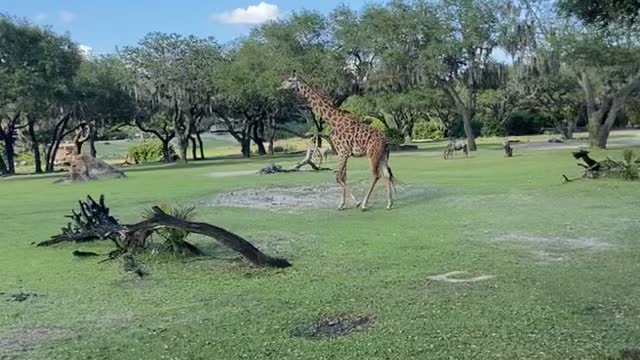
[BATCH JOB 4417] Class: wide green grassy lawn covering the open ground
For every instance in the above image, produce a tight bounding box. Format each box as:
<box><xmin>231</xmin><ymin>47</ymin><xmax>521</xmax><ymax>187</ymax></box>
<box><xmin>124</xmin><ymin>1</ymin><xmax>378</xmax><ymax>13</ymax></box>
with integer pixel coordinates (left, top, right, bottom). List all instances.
<box><xmin>0</xmin><ymin>144</ymin><xmax>640</xmax><ymax>359</ymax></box>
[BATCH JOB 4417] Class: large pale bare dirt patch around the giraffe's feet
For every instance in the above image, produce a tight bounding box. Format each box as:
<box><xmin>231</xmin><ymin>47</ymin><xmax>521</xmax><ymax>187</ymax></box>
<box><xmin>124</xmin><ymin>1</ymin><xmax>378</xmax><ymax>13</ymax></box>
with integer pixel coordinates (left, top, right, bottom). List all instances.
<box><xmin>205</xmin><ymin>181</ymin><xmax>436</xmax><ymax>210</ymax></box>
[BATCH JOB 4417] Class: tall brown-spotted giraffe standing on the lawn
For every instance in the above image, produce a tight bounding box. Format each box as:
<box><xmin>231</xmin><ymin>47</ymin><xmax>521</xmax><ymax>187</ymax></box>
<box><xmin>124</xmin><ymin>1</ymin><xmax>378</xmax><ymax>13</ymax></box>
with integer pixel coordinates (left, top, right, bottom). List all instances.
<box><xmin>281</xmin><ymin>72</ymin><xmax>394</xmax><ymax>210</ymax></box>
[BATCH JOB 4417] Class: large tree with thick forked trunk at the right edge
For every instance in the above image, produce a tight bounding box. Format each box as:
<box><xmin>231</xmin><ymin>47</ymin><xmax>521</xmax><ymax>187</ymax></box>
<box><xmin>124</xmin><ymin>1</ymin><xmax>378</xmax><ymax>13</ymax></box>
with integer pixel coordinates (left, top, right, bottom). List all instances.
<box><xmin>502</xmin><ymin>1</ymin><xmax>640</xmax><ymax>148</ymax></box>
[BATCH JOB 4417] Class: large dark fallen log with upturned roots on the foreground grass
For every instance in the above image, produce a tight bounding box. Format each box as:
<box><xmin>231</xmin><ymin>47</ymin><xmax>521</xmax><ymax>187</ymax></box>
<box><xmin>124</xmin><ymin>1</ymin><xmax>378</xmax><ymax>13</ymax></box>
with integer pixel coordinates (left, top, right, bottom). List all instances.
<box><xmin>37</xmin><ymin>195</ymin><xmax>291</xmax><ymax>268</ymax></box>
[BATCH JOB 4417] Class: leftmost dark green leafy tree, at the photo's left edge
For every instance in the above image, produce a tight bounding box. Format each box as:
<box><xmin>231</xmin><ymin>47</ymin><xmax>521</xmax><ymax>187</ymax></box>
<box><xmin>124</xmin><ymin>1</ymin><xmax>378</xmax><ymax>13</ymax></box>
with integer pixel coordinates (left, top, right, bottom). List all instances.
<box><xmin>0</xmin><ymin>17</ymin><xmax>80</xmax><ymax>172</ymax></box>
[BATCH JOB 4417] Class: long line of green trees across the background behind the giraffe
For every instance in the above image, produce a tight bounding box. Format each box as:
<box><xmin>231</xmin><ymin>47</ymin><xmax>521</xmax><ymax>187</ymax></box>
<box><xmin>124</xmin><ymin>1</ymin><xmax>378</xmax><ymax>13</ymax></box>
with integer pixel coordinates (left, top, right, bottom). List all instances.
<box><xmin>0</xmin><ymin>0</ymin><xmax>640</xmax><ymax>174</ymax></box>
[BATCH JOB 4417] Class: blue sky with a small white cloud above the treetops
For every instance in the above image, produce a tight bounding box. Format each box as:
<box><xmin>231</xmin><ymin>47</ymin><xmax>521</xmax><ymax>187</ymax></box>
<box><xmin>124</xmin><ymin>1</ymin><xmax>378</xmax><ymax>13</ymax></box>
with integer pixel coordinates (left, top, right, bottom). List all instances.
<box><xmin>0</xmin><ymin>0</ymin><xmax>382</xmax><ymax>54</ymax></box>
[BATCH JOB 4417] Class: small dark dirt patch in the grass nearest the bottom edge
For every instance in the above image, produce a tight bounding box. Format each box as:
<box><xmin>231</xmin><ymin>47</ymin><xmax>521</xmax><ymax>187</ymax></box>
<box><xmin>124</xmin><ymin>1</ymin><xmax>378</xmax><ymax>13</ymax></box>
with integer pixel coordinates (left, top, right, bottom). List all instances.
<box><xmin>291</xmin><ymin>315</ymin><xmax>373</xmax><ymax>339</ymax></box>
